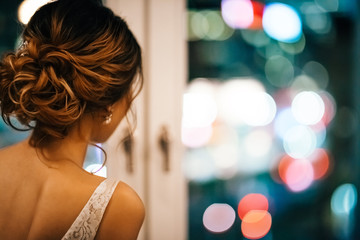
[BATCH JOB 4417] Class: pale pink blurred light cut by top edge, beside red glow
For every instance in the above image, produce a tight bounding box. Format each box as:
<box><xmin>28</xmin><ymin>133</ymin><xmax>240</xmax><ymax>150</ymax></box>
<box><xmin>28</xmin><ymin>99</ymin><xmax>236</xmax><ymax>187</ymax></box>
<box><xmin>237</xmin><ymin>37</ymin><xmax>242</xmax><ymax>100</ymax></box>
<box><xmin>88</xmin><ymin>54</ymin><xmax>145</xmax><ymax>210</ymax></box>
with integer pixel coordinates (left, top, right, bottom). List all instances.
<box><xmin>221</xmin><ymin>0</ymin><xmax>254</xmax><ymax>28</ymax></box>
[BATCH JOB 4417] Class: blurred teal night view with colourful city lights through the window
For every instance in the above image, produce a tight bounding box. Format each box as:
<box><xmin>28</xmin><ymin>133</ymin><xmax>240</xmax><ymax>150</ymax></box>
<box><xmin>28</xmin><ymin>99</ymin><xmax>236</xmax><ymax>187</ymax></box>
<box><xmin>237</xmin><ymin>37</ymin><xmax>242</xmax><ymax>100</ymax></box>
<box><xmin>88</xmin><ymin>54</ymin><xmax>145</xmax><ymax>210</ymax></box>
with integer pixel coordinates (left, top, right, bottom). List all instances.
<box><xmin>0</xmin><ymin>0</ymin><xmax>360</xmax><ymax>240</ymax></box>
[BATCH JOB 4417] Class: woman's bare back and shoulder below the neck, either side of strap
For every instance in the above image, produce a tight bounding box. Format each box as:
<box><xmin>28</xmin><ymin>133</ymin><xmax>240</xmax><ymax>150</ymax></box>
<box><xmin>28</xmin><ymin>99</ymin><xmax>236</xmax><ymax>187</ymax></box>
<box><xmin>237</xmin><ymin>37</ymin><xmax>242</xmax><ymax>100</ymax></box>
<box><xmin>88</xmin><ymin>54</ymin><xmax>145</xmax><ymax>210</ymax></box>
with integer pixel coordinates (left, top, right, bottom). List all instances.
<box><xmin>0</xmin><ymin>142</ymin><xmax>144</xmax><ymax>240</ymax></box>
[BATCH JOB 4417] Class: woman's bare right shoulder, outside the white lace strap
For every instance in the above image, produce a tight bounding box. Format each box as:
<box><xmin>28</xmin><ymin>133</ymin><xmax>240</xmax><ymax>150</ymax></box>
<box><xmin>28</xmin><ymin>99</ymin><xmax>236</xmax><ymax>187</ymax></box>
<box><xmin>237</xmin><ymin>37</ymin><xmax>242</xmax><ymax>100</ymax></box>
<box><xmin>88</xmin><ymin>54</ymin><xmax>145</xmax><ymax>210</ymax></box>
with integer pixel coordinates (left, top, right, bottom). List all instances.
<box><xmin>96</xmin><ymin>182</ymin><xmax>145</xmax><ymax>240</ymax></box>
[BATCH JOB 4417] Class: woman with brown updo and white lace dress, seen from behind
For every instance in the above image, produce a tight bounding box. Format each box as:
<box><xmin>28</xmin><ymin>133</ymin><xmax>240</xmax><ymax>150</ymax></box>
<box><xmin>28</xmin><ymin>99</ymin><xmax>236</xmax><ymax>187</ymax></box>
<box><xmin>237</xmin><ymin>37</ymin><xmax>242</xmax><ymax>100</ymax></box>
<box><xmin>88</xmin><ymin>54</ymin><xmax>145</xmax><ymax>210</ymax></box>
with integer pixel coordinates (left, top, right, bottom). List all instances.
<box><xmin>0</xmin><ymin>0</ymin><xmax>144</xmax><ymax>240</ymax></box>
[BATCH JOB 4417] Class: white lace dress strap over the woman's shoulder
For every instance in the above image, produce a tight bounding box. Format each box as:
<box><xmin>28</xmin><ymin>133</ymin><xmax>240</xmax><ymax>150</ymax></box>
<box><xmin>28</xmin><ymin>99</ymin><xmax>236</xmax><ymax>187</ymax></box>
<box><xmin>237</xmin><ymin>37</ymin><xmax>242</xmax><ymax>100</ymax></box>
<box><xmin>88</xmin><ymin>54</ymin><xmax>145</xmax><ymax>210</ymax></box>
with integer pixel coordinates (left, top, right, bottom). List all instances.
<box><xmin>62</xmin><ymin>179</ymin><xmax>118</xmax><ymax>240</ymax></box>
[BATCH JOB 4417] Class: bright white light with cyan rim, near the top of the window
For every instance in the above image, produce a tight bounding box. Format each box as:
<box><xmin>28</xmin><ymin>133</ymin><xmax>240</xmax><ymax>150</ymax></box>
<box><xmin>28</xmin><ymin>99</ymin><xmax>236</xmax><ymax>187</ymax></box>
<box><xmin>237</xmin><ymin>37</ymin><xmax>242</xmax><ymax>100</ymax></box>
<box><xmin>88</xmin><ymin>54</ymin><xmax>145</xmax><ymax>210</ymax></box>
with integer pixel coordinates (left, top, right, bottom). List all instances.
<box><xmin>263</xmin><ymin>3</ymin><xmax>302</xmax><ymax>43</ymax></box>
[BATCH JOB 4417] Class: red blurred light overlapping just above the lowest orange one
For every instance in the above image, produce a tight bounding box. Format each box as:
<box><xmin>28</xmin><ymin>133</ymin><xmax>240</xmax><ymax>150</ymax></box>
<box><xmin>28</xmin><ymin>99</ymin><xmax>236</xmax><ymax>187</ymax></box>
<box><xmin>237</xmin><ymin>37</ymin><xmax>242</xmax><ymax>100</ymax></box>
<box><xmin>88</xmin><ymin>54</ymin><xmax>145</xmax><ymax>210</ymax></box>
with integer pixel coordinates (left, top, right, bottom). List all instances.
<box><xmin>238</xmin><ymin>193</ymin><xmax>269</xmax><ymax>220</ymax></box>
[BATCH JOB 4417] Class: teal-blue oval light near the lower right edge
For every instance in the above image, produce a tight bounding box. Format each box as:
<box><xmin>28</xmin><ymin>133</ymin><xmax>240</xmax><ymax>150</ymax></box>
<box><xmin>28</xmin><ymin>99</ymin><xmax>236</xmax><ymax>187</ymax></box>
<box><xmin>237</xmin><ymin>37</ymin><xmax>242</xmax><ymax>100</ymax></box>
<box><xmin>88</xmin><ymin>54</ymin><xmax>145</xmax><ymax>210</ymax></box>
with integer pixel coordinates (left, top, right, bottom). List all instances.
<box><xmin>331</xmin><ymin>183</ymin><xmax>358</xmax><ymax>215</ymax></box>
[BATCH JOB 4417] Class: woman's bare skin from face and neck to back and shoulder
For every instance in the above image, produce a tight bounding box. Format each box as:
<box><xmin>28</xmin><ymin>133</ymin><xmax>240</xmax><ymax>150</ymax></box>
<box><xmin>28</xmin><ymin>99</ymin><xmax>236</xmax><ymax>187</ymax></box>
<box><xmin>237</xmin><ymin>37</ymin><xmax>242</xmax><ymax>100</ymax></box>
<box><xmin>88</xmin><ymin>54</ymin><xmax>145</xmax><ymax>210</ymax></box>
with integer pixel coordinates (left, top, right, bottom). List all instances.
<box><xmin>0</xmin><ymin>96</ymin><xmax>144</xmax><ymax>240</ymax></box>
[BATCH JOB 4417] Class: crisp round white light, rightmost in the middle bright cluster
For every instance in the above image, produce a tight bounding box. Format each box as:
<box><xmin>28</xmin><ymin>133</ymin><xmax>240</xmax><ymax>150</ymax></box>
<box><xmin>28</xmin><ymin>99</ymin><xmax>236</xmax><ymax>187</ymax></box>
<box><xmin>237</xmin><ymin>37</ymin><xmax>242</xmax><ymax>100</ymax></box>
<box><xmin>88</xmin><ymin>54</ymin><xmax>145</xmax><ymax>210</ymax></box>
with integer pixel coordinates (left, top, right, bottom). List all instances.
<box><xmin>291</xmin><ymin>91</ymin><xmax>325</xmax><ymax>125</ymax></box>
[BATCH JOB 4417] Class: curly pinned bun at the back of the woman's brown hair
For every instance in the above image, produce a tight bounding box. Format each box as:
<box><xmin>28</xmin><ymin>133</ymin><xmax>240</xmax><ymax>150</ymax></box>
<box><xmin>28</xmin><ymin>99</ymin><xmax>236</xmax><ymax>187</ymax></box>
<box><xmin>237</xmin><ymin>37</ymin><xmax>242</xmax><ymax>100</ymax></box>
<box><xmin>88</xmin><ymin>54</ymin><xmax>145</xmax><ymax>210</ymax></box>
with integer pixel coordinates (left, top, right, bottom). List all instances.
<box><xmin>0</xmin><ymin>43</ymin><xmax>85</xmax><ymax>137</ymax></box>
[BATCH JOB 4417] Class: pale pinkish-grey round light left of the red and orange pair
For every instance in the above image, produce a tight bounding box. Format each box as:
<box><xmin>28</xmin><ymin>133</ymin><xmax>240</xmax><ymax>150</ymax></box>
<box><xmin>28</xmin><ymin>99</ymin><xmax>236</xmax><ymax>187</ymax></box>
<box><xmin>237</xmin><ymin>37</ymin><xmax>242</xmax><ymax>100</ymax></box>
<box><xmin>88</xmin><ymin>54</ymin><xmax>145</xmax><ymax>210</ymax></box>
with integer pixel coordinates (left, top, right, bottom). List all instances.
<box><xmin>203</xmin><ymin>203</ymin><xmax>236</xmax><ymax>233</ymax></box>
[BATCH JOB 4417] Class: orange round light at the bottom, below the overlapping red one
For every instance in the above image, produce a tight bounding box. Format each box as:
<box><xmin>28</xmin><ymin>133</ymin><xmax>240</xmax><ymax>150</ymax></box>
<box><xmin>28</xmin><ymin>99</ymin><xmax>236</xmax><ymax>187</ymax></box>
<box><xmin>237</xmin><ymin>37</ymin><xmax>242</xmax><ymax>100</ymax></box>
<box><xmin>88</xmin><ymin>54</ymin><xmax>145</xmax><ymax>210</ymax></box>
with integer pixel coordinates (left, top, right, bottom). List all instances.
<box><xmin>241</xmin><ymin>210</ymin><xmax>272</xmax><ymax>239</ymax></box>
